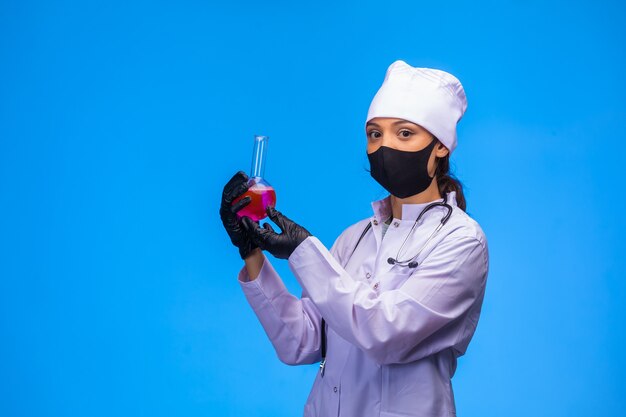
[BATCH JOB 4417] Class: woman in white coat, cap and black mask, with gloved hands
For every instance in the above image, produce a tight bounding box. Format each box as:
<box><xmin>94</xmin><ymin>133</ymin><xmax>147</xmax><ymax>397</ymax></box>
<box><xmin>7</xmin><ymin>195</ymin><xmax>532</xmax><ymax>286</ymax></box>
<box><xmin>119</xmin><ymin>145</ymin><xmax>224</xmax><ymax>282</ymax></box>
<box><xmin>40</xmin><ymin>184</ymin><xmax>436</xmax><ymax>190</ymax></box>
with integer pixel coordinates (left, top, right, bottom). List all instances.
<box><xmin>220</xmin><ymin>61</ymin><xmax>489</xmax><ymax>417</ymax></box>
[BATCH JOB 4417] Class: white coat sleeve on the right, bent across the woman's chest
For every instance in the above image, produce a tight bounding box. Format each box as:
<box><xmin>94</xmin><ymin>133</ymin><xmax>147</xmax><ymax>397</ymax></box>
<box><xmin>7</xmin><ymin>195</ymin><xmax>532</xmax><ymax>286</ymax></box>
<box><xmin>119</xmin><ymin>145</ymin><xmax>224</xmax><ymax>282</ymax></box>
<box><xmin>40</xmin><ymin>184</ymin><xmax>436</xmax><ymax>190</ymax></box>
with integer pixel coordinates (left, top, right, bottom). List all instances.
<box><xmin>289</xmin><ymin>236</ymin><xmax>488</xmax><ymax>364</ymax></box>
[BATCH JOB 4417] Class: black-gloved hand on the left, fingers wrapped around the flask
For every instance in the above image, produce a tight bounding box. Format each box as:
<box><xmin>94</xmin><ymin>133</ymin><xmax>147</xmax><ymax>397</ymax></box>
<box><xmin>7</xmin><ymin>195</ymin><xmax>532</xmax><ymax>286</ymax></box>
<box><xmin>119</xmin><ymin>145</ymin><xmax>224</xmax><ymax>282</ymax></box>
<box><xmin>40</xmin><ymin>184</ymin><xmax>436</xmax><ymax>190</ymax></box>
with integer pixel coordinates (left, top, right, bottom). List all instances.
<box><xmin>220</xmin><ymin>171</ymin><xmax>259</xmax><ymax>259</ymax></box>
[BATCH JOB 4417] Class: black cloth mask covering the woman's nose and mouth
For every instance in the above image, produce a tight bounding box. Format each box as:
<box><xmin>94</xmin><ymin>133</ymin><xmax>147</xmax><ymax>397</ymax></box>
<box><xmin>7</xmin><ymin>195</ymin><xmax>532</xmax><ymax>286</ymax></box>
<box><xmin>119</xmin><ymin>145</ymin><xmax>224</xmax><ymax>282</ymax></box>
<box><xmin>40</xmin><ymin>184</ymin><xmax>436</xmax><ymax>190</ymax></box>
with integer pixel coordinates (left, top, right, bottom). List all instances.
<box><xmin>367</xmin><ymin>138</ymin><xmax>436</xmax><ymax>198</ymax></box>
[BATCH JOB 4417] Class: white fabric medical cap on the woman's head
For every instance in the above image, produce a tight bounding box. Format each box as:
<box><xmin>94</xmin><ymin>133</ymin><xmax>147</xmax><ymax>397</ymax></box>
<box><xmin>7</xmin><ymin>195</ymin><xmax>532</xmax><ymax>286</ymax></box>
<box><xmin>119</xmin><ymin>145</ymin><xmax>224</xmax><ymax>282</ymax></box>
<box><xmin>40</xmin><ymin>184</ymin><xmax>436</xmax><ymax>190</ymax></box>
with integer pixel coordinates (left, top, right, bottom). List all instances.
<box><xmin>366</xmin><ymin>61</ymin><xmax>467</xmax><ymax>153</ymax></box>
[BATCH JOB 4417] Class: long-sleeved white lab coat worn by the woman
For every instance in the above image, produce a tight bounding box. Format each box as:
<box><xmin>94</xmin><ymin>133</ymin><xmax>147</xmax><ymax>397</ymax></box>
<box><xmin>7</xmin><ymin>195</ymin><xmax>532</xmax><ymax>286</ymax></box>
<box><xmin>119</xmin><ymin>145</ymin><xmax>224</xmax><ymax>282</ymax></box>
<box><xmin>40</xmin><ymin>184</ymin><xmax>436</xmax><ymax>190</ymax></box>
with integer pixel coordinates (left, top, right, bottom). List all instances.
<box><xmin>238</xmin><ymin>192</ymin><xmax>489</xmax><ymax>417</ymax></box>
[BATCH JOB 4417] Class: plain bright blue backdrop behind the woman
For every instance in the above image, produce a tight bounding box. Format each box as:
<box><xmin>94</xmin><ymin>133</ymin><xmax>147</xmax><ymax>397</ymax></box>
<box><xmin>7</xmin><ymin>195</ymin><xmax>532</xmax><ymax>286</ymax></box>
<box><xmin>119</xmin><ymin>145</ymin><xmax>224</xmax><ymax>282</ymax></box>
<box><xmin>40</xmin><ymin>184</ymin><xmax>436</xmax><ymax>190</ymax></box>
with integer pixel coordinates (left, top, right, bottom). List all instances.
<box><xmin>0</xmin><ymin>0</ymin><xmax>626</xmax><ymax>417</ymax></box>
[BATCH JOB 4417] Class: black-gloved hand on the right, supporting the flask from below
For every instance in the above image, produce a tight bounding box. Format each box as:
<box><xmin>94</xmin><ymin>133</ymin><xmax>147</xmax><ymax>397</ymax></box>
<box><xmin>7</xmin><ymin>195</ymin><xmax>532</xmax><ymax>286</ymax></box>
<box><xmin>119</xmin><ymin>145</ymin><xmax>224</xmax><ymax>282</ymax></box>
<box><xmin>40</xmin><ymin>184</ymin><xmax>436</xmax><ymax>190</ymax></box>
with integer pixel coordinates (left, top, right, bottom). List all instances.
<box><xmin>241</xmin><ymin>207</ymin><xmax>311</xmax><ymax>259</ymax></box>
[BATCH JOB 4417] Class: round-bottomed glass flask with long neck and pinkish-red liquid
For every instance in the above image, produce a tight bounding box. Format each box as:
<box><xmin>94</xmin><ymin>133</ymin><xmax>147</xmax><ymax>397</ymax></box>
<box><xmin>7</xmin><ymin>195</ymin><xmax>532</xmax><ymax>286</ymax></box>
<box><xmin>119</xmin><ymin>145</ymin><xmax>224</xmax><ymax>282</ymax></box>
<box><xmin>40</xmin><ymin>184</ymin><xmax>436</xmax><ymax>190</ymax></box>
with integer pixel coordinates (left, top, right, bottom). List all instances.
<box><xmin>233</xmin><ymin>135</ymin><xmax>276</xmax><ymax>221</ymax></box>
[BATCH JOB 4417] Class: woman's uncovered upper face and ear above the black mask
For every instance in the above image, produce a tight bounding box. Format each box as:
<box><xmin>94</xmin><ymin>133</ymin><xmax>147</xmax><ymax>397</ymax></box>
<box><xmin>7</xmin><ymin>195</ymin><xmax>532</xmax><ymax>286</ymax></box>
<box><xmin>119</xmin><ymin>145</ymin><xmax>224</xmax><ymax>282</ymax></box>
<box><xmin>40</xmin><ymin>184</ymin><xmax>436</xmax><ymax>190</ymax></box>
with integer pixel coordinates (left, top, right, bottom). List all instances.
<box><xmin>365</xmin><ymin>117</ymin><xmax>448</xmax><ymax>176</ymax></box>
